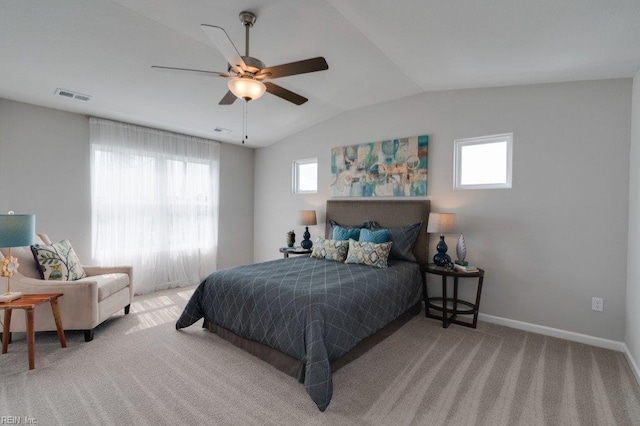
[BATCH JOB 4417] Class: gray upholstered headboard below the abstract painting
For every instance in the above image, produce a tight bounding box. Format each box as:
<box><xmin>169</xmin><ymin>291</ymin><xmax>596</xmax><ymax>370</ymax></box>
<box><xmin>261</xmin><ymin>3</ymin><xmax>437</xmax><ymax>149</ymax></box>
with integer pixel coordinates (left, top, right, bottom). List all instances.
<box><xmin>325</xmin><ymin>200</ymin><xmax>430</xmax><ymax>265</ymax></box>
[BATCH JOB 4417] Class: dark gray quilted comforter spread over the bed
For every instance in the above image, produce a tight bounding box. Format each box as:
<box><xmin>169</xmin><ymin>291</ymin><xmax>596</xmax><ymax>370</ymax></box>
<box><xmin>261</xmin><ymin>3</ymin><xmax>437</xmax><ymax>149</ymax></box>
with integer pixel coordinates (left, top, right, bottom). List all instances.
<box><xmin>176</xmin><ymin>257</ymin><xmax>422</xmax><ymax>411</ymax></box>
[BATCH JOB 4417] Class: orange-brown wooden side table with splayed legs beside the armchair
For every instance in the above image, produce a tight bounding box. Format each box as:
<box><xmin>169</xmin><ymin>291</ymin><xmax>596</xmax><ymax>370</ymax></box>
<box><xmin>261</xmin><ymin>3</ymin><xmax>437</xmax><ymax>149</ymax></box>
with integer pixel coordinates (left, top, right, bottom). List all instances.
<box><xmin>0</xmin><ymin>293</ymin><xmax>67</xmax><ymax>370</ymax></box>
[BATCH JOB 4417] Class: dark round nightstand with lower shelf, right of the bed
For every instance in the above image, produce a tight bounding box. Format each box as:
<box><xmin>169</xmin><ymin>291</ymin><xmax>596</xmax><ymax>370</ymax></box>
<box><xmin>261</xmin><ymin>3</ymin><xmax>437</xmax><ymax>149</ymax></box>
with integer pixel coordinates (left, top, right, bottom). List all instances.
<box><xmin>424</xmin><ymin>263</ymin><xmax>484</xmax><ymax>328</ymax></box>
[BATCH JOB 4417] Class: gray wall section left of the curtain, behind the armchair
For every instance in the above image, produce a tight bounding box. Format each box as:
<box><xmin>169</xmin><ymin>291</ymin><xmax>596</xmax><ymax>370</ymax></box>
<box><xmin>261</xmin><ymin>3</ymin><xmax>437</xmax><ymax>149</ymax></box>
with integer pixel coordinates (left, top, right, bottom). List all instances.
<box><xmin>0</xmin><ymin>99</ymin><xmax>91</xmax><ymax>258</ymax></box>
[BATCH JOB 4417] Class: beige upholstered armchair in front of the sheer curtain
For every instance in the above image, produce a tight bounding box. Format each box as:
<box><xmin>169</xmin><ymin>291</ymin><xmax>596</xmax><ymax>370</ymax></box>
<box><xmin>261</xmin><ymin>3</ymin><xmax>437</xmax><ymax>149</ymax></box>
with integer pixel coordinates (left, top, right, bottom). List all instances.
<box><xmin>0</xmin><ymin>234</ymin><xmax>133</xmax><ymax>342</ymax></box>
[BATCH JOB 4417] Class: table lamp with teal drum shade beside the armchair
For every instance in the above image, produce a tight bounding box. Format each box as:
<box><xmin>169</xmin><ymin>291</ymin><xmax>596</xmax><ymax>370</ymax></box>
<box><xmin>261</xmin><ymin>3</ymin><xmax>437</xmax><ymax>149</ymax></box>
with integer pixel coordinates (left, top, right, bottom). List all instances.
<box><xmin>0</xmin><ymin>212</ymin><xmax>36</xmax><ymax>302</ymax></box>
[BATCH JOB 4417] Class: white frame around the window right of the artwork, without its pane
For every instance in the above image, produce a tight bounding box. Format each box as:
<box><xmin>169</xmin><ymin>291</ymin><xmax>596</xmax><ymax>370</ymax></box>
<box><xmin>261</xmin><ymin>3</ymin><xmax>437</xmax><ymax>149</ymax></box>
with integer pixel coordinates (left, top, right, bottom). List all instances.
<box><xmin>453</xmin><ymin>133</ymin><xmax>513</xmax><ymax>189</ymax></box>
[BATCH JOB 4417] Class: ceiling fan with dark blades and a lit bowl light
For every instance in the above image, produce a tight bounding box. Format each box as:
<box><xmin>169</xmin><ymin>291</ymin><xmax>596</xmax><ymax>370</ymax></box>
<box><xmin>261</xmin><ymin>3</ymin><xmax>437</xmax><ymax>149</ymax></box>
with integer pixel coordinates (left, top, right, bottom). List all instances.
<box><xmin>152</xmin><ymin>11</ymin><xmax>329</xmax><ymax>105</ymax></box>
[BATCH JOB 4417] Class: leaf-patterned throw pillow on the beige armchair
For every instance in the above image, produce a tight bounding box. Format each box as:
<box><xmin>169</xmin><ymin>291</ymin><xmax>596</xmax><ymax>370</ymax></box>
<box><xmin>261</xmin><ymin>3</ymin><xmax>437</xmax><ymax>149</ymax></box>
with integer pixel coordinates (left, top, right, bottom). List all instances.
<box><xmin>31</xmin><ymin>240</ymin><xmax>87</xmax><ymax>281</ymax></box>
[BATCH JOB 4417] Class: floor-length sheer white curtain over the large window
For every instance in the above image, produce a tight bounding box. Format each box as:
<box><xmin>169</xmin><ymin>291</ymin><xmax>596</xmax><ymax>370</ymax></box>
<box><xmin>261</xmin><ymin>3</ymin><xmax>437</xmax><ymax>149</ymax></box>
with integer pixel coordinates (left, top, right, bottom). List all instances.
<box><xmin>89</xmin><ymin>117</ymin><xmax>220</xmax><ymax>294</ymax></box>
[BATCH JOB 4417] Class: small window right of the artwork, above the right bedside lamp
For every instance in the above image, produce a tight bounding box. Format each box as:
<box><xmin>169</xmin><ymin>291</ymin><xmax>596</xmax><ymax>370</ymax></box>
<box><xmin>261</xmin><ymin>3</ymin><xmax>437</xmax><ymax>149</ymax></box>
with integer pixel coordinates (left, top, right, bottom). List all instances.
<box><xmin>453</xmin><ymin>133</ymin><xmax>513</xmax><ymax>189</ymax></box>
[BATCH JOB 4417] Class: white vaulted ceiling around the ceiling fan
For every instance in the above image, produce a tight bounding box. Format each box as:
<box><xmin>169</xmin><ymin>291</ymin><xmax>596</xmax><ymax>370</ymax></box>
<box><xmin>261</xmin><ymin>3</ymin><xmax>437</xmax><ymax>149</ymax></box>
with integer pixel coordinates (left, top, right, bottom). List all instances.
<box><xmin>0</xmin><ymin>0</ymin><xmax>640</xmax><ymax>147</ymax></box>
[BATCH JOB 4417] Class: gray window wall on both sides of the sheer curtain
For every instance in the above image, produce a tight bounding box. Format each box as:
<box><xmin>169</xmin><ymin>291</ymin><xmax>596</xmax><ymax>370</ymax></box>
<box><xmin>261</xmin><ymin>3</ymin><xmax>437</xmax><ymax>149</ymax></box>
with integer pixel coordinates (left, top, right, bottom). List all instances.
<box><xmin>0</xmin><ymin>98</ymin><xmax>253</xmax><ymax>269</ymax></box>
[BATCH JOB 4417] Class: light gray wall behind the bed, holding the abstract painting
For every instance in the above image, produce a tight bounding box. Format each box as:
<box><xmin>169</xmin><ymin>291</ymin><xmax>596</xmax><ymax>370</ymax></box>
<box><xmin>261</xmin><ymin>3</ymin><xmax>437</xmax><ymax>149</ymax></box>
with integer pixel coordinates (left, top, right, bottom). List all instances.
<box><xmin>255</xmin><ymin>79</ymin><xmax>632</xmax><ymax>341</ymax></box>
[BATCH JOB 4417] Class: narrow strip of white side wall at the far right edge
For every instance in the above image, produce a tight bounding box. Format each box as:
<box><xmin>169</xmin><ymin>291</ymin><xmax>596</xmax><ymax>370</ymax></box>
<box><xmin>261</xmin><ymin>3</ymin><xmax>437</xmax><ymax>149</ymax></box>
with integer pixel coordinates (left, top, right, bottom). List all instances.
<box><xmin>625</xmin><ymin>71</ymin><xmax>640</xmax><ymax>372</ymax></box>
